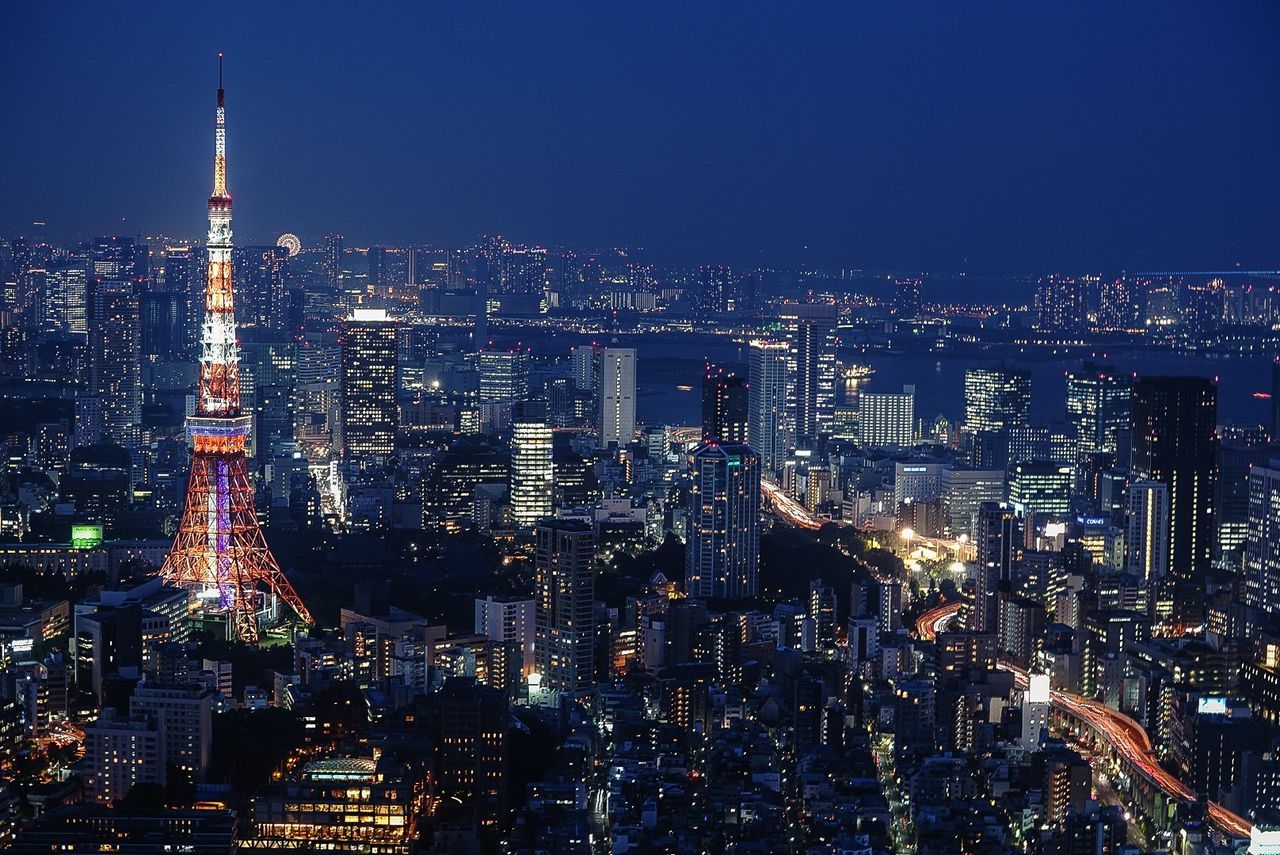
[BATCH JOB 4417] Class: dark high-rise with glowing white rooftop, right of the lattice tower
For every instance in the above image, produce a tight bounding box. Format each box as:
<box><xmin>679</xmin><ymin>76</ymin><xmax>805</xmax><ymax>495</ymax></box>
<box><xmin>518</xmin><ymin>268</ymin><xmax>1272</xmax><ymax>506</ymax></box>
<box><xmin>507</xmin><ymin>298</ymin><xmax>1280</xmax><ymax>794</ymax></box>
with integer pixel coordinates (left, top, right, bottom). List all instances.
<box><xmin>342</xmin><ymin>308</ymin><xmax>399</xmax><ymax>463</ymax></box>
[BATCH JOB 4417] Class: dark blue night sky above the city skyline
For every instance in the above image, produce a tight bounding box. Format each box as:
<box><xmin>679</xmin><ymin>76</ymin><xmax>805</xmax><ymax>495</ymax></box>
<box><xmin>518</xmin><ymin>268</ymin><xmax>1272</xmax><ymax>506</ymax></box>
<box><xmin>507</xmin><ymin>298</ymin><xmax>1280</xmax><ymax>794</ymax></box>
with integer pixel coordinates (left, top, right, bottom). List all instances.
<box><xmin>0</xmin><ymin>0</ymin><xmax>1280</xmax><ymax>271</ymax></box>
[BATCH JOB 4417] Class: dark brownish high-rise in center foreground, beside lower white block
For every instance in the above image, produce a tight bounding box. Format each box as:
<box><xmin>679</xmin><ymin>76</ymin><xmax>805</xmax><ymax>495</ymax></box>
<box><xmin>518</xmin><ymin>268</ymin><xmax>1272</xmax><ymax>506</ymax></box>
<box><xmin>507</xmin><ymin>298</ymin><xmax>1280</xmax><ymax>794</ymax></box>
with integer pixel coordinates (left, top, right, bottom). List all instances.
<box><xmin>534</xmin><ymin>520</ymin><xmax>595</xmax><ymax>698</ymax></box>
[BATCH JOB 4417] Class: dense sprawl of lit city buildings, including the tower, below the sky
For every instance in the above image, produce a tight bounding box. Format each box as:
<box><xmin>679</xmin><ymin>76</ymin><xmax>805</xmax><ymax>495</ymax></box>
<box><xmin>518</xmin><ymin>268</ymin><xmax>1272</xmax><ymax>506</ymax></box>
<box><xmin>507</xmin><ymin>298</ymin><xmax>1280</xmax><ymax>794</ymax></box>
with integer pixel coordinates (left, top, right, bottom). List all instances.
<box><xmin>0</xmin><ymin>71</ymin><xmax>1280</xmax><ymax>855</ymax></box>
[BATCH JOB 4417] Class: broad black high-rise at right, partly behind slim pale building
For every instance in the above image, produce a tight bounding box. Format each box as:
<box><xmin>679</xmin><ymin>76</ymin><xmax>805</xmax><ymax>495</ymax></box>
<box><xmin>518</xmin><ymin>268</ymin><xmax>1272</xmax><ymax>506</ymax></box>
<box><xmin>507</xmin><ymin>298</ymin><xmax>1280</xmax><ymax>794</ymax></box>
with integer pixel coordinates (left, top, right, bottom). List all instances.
<box><xmin>1129</xmin><ymin>376</ymin><xmax>1217</xmax><ymax>626</ymax></box>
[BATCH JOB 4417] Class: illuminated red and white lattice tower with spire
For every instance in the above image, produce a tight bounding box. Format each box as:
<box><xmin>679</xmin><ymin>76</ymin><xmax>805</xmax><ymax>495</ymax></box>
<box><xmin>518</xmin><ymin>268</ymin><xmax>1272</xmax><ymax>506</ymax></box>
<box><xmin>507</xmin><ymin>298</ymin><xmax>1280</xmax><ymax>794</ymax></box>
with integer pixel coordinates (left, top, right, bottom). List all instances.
<box><xmin>160</xmin><ymin>54</ymin><xmax>312</xmax><ymax>643</ymax></box>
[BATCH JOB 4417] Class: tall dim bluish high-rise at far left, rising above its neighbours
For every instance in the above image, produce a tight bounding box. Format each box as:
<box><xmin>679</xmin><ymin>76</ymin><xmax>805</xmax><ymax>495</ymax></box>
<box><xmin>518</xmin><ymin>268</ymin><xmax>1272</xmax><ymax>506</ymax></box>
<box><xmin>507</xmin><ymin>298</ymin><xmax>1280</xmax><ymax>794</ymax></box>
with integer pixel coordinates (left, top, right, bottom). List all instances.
<box><xmin>88</xmin><ymin>275</ymin><xmax>142</xmax><ymax>447</ymax></box>
